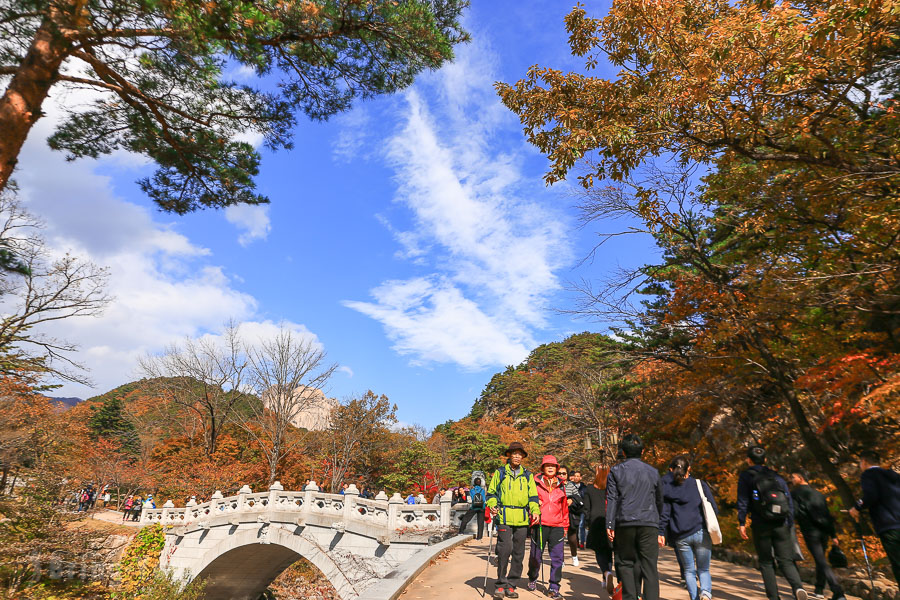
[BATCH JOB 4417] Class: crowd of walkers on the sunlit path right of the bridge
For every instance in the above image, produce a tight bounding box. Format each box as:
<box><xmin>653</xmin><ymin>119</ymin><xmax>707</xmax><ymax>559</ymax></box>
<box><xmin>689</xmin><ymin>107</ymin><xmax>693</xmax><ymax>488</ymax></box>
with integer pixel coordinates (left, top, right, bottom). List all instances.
<box><xmin>474</xmin><ymin>434</ymin><xmax>900</xmax><ymax>600</ymax></box>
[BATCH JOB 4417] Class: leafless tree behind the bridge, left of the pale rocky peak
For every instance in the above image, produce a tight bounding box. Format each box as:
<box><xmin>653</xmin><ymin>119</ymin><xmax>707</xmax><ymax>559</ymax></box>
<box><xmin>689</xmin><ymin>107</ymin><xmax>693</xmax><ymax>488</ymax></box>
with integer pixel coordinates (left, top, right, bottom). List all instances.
<box><xmin>140</xmin><ymin>323</ymin><xmax>249</xmax><ymax>456</ymax></box>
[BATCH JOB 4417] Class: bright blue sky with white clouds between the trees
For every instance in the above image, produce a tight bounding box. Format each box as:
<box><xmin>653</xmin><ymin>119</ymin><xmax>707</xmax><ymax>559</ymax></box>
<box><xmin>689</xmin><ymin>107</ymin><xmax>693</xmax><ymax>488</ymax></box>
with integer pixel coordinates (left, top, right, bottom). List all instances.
<box><xmin>16</xmin><ymin>1</ymin><xmax>652</xmax><ymax>427</ymax></box>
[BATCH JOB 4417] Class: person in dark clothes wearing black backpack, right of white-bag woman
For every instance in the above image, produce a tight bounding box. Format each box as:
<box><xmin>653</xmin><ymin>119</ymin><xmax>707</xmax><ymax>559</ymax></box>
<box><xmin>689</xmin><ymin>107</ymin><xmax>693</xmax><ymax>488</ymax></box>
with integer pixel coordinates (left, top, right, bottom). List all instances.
<box><xmin>737</xmin><ymin>446</ymin><xmax>809</xmax><ymax>600</ymax></box>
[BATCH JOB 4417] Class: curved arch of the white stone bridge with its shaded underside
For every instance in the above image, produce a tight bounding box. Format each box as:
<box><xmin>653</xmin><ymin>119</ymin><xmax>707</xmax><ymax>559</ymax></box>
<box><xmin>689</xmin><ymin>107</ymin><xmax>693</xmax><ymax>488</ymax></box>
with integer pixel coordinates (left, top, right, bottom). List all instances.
<box><xmin>185</xmin><ymin>528</ymin><xmax>358</xmax><ymax>600</ymax></box>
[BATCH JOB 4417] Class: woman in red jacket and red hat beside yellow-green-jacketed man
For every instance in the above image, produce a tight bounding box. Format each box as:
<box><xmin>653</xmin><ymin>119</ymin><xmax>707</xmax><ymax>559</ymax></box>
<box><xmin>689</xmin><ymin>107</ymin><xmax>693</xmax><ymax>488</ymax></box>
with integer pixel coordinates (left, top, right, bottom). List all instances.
<box><xmin>528</xmin><ymin>455</ymin><xmax>569</xmax><ymax>598</ymax></box>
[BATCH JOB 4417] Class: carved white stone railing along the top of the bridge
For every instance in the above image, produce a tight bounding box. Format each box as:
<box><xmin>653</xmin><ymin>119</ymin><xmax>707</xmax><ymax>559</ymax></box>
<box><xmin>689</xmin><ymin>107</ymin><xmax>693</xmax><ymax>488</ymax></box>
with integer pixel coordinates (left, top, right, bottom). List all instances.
<box><xmin>141</xmin><ymin>481</ymin><xmax>468</xmax><ymax>537</ymax></box>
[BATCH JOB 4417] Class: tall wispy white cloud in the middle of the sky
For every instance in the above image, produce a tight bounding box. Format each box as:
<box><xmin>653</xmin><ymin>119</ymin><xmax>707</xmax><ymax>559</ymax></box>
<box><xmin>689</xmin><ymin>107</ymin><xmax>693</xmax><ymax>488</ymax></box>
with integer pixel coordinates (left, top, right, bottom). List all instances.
<box><xmin>345</xmin><ymin>45</ymin><xmax>570</xmax><ymax>369</ymax></box>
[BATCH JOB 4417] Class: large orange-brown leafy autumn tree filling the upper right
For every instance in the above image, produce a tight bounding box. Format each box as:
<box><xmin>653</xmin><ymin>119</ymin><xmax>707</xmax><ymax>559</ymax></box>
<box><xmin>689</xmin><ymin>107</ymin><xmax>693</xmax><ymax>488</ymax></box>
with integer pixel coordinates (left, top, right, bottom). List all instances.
<box><xmin>498</xmin><ymin>0</ymin><xmax>900</xmax><ymax>503</ymax></box>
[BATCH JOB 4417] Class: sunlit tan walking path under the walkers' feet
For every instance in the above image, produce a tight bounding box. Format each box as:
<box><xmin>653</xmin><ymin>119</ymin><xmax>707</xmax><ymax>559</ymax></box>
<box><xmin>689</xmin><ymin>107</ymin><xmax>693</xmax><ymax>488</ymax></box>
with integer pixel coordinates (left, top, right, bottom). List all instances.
<box><xmin>401</xmin><ymin>535</ymin><xmax>858</xmax><ymax>600</ymax></box>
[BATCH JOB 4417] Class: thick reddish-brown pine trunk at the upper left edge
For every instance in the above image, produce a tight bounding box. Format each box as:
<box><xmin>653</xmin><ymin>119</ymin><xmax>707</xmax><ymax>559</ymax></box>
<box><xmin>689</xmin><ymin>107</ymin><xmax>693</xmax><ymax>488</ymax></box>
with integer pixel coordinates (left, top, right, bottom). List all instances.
<box><xmin>0</xmin><ymin>20</ymin><xmax>71</xmax><ymax>191</ymax></box>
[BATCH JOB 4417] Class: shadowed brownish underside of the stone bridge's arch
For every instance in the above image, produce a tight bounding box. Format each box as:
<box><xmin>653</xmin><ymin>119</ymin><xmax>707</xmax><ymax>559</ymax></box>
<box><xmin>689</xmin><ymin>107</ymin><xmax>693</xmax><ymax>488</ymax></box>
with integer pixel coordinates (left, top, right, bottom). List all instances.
<box><xmin>199</xmin><ymin>544</ymin><xmax>300</xmax><ymax>600</ymax></box>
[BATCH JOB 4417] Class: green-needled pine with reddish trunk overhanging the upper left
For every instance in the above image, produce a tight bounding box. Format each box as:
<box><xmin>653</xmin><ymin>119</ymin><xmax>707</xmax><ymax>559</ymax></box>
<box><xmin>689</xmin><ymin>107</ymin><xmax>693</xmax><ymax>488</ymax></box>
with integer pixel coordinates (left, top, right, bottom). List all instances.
<box><xmin>0</xmin><ymin>0</ymin><xmax>467</xmax><ymax>214</ymax></box>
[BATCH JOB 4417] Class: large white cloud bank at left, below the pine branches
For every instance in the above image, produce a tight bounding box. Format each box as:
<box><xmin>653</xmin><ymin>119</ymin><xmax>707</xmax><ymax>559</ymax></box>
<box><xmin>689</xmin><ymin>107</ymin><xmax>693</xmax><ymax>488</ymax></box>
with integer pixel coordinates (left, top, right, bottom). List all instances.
<box><xmin>9</xmin><ymin>84</ymin><xmax>315</xmax><ymax>397</ymax></box>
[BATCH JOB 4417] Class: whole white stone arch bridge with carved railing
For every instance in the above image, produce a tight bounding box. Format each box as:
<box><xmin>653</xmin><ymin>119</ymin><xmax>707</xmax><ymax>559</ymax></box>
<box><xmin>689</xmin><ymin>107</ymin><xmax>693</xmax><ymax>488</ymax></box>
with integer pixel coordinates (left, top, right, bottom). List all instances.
<box><xmin>141</xmin><ymin>482</ymin><xmax>469</xmax><ymax>600</ymax></box>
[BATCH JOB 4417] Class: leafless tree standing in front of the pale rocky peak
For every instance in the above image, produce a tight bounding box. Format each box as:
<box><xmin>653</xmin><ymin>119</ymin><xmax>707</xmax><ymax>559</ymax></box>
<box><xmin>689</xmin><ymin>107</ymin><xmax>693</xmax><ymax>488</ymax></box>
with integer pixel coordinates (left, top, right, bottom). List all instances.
<box><xmin>235</xmin><ymin>326</ymin><xmax>337</xmax><ymax>485</ymax></box>
